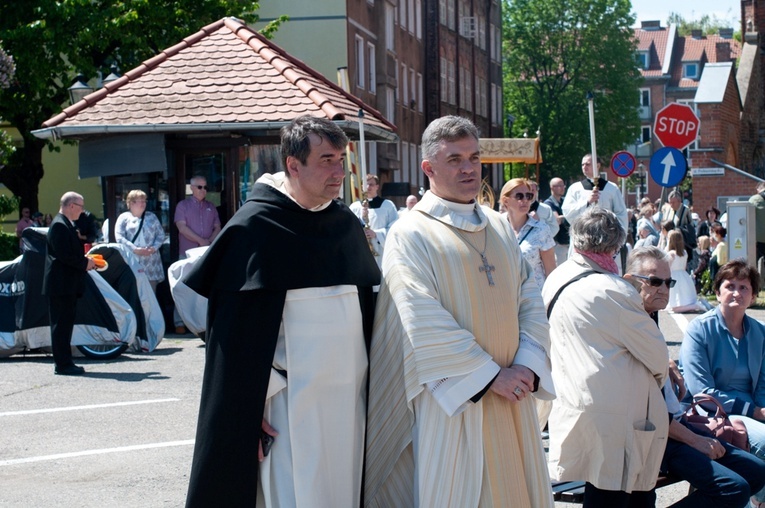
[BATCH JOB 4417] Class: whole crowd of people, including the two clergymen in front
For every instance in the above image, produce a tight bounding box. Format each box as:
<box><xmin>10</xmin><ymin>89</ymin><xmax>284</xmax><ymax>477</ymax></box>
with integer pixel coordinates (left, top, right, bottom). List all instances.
<box><xmin>17</xmin><ymin>112</ymin><xmax>765</xmax><ymax>508</ymax></box>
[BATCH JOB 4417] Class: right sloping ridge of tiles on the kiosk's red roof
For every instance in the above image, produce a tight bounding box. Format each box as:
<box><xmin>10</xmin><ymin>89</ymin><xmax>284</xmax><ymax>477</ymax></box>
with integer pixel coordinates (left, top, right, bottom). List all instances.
<box><xmin>222</xmin><ymin>17</ymin><xmax>396</xmax><ymax>130</ymax></box>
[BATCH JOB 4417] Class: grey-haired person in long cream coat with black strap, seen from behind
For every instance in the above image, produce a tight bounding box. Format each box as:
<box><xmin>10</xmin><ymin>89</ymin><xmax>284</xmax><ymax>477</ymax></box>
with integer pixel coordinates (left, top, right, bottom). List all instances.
<box><xmin>542</xmin><ymin>207</ymin><xmax>669</xmax><ymax>507</ymax></box>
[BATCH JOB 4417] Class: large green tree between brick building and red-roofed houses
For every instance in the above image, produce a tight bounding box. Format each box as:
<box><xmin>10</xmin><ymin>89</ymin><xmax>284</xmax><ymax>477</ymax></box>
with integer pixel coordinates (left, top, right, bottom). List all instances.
<box><xmin>503</xmin><ymin>0</ymin><xmax>642</xmax><ymax>180</ymax></box>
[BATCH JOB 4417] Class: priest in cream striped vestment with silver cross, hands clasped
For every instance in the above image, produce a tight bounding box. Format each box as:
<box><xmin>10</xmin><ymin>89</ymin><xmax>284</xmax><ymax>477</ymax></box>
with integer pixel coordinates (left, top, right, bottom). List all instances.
<box><xmin>364</xmin><ymin>116</ymin><xmax>554</xmax><ymax>508</ymax></box>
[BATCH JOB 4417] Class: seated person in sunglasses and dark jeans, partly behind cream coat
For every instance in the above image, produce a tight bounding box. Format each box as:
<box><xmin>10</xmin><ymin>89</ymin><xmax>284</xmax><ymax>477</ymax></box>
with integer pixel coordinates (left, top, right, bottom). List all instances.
<box><xmin>624</xmin><ymin>251</ymin><xmax>765</xmax><ymax>508</ymax></box>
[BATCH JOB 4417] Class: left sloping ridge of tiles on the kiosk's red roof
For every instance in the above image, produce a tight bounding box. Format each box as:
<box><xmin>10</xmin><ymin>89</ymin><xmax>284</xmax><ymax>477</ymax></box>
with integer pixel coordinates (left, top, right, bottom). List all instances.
<box><xmin>42</xmin><ymin>18</ymin><xmax>225</xmax><ymax>127</ymax></box>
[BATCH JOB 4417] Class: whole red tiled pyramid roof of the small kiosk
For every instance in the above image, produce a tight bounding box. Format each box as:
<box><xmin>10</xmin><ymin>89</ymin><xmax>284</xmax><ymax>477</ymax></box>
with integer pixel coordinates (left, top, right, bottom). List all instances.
<box><xmin>43</xmin><ymin>18</ymin><xmax>395</xmax><ymax>139</ymax></box>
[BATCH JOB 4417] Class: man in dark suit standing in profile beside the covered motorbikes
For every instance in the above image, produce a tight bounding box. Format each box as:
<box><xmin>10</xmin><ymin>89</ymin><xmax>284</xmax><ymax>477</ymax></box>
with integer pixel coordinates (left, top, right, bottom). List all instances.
<box><xmin>43</xmin><ymin>192</ymin><xmax>96</xmax><ymax>376</ymax></box>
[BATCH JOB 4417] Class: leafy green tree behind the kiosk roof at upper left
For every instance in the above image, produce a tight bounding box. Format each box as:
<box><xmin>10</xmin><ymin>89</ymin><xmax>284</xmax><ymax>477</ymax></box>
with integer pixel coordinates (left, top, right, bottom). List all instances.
<box><xmin>0</xmin><ymin>0</ymin><xmax>282</xmax><ymax>214</ymax></box>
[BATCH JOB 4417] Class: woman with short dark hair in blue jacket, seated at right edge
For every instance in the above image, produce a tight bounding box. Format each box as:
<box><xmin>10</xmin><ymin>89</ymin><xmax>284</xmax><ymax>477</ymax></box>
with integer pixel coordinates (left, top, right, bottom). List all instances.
<box><xmin>680</xmin><ymin>259</ymin><xmax>765</xmax><ymax>507</ymax></box>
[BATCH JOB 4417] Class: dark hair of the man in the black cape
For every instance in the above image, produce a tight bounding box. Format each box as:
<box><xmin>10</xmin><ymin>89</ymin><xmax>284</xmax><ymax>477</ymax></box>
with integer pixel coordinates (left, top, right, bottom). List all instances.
<box><xmin>281</xmin><ymin>115</ymin><xmax>348</xmax><ymax>171</ymax></box>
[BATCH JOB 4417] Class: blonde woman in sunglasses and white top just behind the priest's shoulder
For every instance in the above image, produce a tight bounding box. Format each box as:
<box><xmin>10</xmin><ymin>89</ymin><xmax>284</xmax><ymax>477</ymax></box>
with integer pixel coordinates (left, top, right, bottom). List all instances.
<box><xmin>499</xmin><ymin>178</ymin><xmax>556</xmax><ymax>290</ymax></box>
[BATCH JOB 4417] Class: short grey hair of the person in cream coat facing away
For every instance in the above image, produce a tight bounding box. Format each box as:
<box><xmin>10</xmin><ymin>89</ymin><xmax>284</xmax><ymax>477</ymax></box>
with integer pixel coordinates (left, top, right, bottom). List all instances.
<box><xmin>571</xmin><ymin>206</ymin><xmax>627</xmax><ymax>254</ymax></box>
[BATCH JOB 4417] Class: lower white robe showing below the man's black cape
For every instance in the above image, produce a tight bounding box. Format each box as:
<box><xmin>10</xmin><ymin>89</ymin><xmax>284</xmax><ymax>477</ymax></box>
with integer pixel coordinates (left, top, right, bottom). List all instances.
<box><xmin>258</xmin><ymin>286</ymin><xmax>367</xmax><ymax>508</ymax></box>
